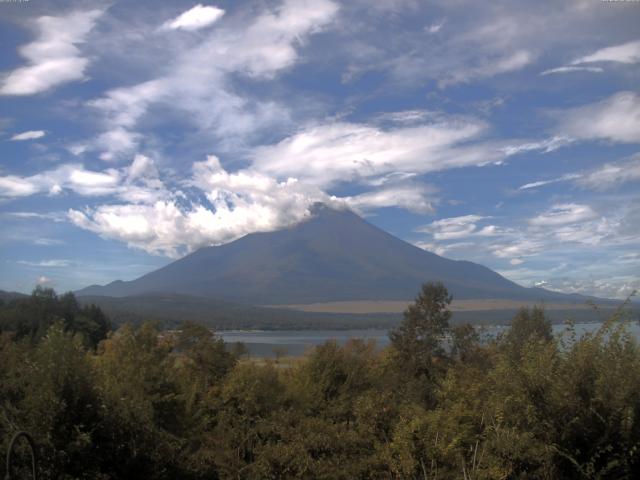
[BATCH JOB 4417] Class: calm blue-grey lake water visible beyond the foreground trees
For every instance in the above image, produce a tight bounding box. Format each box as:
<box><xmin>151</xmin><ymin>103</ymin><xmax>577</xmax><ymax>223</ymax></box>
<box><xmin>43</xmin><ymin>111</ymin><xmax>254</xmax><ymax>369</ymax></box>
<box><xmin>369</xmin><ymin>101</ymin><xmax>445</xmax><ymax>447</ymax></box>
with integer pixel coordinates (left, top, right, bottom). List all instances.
<box><xmin>218</xmin><ymin>322</ymin><xmax>640</xmax><ymax>357</ymax></box>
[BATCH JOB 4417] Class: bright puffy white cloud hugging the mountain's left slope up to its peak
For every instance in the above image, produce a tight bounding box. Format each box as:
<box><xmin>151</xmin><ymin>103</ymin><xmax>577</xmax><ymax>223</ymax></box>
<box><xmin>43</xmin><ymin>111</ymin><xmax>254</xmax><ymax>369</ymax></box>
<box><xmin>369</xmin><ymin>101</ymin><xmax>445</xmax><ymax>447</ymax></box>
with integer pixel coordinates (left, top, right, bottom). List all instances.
<box><xmin>69</xmin><ymin>156</ymin><xmax>330</xmax><ymax>257</ymax></box>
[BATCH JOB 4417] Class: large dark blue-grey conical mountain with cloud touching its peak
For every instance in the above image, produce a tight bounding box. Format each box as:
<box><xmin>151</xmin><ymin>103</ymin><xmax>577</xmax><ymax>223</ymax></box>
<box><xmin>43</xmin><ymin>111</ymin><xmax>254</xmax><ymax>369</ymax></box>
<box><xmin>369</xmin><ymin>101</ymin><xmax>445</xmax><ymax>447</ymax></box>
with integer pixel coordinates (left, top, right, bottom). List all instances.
<box><xmin>76</xmin><ymin>206</ymin><xmax>592</xmax><ymax>305</ymax></box>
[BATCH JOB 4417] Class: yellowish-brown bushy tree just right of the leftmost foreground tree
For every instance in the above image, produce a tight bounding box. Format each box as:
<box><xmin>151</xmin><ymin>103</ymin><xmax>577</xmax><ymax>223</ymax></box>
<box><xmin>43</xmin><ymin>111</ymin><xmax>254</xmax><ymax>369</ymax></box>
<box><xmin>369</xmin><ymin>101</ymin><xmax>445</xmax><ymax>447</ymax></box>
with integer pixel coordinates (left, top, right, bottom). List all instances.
<box><xmin>95</xmin><ymin>323</ymin><xmax>184</xmax><ymax>479</ymax></box>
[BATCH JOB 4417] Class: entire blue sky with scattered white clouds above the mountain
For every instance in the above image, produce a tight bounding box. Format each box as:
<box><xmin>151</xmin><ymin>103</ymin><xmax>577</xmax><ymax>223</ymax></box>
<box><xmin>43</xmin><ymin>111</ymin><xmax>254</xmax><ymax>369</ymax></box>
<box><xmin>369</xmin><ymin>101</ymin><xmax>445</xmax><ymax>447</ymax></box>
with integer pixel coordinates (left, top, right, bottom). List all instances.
<box><xmin>0</xmin><ymin>0</ymin><xmax>640</xmax><ymax>298</ymax></box>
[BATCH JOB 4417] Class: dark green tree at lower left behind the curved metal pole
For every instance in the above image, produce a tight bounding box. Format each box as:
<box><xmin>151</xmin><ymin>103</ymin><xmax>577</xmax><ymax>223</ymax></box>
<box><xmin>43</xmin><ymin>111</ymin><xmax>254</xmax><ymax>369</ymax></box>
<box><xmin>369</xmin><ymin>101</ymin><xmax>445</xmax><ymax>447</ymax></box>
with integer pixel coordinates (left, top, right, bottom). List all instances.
<box><xmin>0</xmin><ymin>322</ymin><xmax>102</xmax><ymax>479</ymax></box>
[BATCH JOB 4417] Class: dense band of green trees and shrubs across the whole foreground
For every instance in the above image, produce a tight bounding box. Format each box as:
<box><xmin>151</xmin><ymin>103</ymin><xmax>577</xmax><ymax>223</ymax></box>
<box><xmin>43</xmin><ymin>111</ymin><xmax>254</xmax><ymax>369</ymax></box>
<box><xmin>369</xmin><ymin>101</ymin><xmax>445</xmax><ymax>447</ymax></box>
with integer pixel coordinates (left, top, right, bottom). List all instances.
<box><xmin>0</xmin><ymin>284</ymin><xmax>640</xmax><ymax>480</ymax></box>
